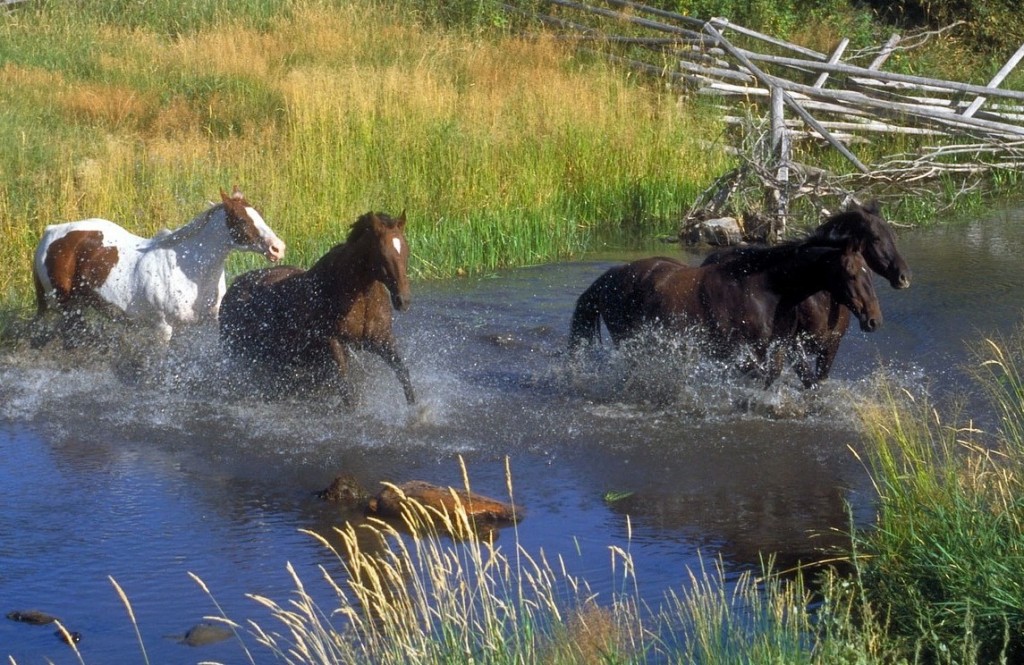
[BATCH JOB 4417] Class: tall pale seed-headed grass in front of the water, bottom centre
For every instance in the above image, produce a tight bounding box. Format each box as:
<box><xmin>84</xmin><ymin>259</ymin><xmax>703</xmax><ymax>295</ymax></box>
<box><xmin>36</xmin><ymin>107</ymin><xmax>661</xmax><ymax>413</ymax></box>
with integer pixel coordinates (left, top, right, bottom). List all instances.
<box><xmin>235</xmin><ymin>456</ymin><xmax>827</xmax><ymax>664</ymax></box>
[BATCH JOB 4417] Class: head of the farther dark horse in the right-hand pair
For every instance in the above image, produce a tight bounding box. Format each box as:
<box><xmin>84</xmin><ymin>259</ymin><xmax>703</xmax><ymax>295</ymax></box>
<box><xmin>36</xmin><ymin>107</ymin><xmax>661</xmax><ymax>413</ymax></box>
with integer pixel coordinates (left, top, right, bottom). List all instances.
<box><xmin>812</xmin><ymin>201</ymin><xmax>910</xmax><ymax>289</ymax></box>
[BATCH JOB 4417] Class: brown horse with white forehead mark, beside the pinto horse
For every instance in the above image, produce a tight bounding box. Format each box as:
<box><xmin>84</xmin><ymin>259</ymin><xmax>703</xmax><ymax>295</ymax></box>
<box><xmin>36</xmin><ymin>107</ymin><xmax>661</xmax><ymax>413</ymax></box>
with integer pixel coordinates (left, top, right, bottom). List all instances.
<box><xmin>220</xmin><ymin>212</ymin><xmax>416</xmax><ymax>404</ymax></box>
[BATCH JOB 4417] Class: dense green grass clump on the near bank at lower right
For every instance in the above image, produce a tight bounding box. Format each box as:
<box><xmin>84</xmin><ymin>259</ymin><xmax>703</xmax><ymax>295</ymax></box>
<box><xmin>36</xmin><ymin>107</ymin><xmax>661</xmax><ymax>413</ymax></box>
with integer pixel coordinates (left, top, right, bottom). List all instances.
<box><xmin>847</xmin><ymin>334</ymin><xmax>1024</xmax><ymax>663</ymax></box>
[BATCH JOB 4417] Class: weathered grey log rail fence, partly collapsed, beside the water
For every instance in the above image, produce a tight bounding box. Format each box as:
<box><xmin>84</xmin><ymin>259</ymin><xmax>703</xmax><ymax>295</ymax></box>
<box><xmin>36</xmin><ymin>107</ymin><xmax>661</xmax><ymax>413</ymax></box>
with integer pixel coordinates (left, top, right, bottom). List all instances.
<box><xmin>504</xmin><ymin>0</ymin><xmax>1024</xmax><ymax>240</ymax></box>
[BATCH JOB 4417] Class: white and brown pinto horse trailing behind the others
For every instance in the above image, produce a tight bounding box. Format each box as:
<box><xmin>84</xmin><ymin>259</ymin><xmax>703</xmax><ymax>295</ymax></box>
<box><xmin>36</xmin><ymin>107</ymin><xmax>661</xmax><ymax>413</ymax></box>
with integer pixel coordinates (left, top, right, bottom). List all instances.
<box><xmin>33</xmin><ymin>185</ymin><xmax>285</xmax><ymax>345</ymax></box>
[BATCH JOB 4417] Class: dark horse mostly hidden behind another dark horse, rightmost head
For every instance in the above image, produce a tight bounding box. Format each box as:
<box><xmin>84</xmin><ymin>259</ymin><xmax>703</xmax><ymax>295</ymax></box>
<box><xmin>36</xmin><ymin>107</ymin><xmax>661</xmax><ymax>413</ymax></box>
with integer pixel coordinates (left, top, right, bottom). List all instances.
<box><xmin>705</xmin><ymin>201</ymin><xmax>910</xmax><ymax>387</ymax></box>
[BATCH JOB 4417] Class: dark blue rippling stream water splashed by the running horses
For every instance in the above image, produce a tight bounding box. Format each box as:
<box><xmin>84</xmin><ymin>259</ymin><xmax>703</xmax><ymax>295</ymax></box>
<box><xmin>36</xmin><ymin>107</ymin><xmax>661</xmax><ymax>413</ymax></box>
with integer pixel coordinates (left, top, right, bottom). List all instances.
<box><xmin>0</xmin><ymin>204</ymin><xmax>1024</xmax><ymax>665</ymax></box>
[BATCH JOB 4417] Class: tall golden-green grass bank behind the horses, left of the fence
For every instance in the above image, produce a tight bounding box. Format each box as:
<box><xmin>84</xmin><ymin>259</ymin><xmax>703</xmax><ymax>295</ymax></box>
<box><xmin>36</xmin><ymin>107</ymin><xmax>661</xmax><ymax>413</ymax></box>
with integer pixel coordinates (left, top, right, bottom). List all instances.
<box><xmin>0</xmin><ymin>0</ymin><xmax>726</xmax><ymax>315</ymax></box>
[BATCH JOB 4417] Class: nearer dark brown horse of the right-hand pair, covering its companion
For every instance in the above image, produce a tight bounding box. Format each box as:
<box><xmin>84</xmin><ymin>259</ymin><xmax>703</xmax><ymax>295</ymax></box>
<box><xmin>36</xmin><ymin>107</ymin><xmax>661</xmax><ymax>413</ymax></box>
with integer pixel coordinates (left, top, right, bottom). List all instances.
<box><xmin>569</xmin><ymin>243</ymin><xmax>882</xmax><ymax>387</ymax></box>
